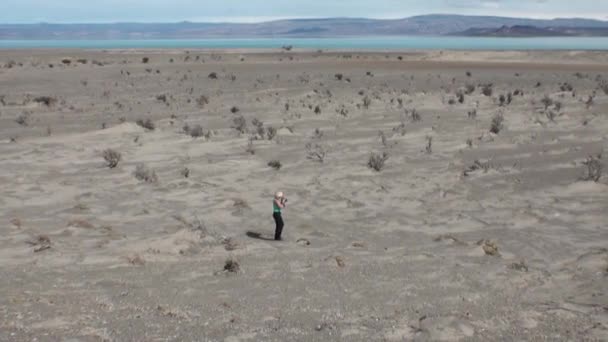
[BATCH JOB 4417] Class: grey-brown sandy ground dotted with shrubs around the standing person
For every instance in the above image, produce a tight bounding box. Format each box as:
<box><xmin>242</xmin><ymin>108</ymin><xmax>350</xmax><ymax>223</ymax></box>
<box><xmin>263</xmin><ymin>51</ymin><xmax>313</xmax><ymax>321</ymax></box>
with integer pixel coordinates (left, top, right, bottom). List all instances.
<box><xmin>0</xmin><ymin>50</ymin><xmax>608</xmax><ymax>341</ymax></box>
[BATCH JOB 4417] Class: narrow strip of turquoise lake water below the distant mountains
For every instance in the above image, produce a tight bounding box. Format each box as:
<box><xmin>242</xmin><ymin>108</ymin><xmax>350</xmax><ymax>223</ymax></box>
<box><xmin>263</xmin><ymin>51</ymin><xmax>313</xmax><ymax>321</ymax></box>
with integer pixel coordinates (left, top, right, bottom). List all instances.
<box><xmin>0</xmin><ymin>36</ymin><xmax>608</xmax><ymax>50</ymax></box>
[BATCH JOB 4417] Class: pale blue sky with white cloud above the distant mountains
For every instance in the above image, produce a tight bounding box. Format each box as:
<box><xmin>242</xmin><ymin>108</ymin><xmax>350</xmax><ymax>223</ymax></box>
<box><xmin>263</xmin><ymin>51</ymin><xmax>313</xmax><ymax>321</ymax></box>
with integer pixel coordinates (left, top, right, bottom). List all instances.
<box><xmin>0</xmin><ymin>0</ymin><xmax>608</xmax><ymax>23</ymax></box>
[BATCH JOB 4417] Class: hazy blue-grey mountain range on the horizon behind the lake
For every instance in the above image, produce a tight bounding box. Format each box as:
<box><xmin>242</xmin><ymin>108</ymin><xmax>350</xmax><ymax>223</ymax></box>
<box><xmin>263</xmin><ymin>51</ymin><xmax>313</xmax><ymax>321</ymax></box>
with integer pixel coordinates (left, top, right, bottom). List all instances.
<box><xmin>0</xmin><ymin>14</ymin><xmax>608</xmax><ymax>40</ymax></box>
